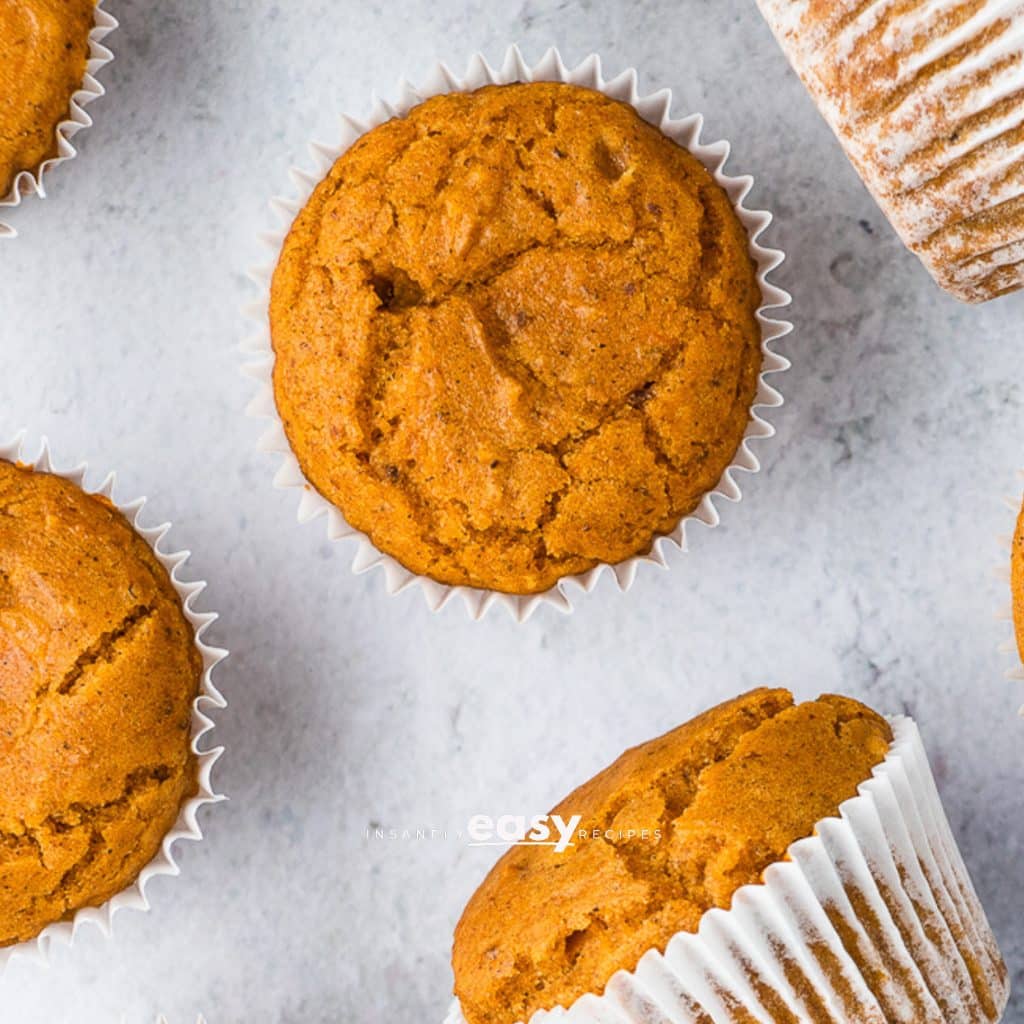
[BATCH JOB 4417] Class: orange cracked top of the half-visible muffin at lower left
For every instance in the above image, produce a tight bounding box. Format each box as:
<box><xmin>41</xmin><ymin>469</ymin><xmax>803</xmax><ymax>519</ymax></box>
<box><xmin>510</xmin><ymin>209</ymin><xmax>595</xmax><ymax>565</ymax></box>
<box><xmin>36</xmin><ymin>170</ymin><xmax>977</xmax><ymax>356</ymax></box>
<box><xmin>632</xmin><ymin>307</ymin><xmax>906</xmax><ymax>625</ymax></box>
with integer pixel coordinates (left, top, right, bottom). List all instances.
<box><xmin>0</xmin><ymin>460</ymin><xmax>203</xmax><ymax>946</ymax></box>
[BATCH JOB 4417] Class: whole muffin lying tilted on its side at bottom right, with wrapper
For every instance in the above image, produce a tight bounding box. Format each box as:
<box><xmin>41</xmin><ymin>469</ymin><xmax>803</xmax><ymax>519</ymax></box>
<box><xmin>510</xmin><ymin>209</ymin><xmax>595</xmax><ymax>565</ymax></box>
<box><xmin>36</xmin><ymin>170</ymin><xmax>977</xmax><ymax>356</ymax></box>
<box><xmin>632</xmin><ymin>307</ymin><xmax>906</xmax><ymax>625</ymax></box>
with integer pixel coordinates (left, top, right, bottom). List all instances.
<box><xmin>450</xmin><ymin>690</ymin><xmax>1007</xmax><ymax>1024</ymax></box>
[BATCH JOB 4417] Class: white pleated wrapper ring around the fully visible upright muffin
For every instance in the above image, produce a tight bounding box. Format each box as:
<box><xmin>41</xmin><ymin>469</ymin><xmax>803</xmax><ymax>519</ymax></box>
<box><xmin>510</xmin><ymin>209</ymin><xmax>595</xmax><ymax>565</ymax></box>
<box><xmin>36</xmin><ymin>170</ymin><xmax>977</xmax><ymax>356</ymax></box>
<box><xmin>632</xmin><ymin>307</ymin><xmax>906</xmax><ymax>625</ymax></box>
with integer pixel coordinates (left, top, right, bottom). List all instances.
<box><xmin>243</xmin><ymin>46</ymin><xmax>793</xmax><ymax>622</ymax></box>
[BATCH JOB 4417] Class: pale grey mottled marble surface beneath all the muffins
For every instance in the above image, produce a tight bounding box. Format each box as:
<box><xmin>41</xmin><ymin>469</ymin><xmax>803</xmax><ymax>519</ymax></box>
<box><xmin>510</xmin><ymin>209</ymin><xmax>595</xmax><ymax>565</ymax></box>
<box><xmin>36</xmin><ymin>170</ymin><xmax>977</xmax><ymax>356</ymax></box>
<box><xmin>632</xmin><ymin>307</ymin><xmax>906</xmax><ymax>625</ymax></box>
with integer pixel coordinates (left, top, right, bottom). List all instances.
<box><xmin>0</xmin><ymin>0</ymin><xmax>1024</xmax><ymax>1024</ymax></box>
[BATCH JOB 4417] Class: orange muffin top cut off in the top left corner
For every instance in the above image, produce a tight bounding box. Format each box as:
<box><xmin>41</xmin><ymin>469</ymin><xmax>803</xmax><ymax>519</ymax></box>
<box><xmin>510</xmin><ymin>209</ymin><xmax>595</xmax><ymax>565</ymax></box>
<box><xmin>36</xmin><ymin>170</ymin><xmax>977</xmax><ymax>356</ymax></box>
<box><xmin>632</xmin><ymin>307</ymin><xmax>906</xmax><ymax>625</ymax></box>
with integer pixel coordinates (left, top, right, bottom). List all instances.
<box><xmin>0</xmin><ymin>0</ymin><xmax>96</xmax><ymax>199</ymax></box>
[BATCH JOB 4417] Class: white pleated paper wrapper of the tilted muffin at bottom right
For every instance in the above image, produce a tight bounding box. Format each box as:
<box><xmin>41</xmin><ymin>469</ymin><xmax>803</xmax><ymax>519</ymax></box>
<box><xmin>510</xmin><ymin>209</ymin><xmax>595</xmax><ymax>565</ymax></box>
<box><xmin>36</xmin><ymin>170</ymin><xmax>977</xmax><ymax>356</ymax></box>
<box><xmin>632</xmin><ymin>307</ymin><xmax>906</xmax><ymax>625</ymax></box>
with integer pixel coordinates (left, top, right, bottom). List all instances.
<box><xmin>445</xmin><ymin>718</ymin><xmax>1010</xmax><ymax>1024</ymax></box>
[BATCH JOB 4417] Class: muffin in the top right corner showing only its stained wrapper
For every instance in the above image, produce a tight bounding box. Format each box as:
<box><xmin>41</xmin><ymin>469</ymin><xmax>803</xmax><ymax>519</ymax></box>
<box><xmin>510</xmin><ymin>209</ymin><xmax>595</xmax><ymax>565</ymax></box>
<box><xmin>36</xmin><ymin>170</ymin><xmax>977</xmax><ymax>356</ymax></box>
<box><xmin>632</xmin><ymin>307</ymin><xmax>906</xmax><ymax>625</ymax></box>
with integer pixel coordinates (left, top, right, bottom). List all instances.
<box><xmin>758</xmin><ymin>0</ymin><xmax>1024</xmax><ymax>302</ymax></box>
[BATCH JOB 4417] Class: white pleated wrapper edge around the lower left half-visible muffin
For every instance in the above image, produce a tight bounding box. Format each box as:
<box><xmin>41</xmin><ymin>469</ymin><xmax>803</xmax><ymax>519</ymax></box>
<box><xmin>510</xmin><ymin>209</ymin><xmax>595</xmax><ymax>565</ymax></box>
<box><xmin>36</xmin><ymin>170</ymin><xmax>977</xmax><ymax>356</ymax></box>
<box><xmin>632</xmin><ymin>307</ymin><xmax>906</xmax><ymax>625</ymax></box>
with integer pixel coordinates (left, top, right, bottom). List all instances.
<box><xmin>0</xmin><ymin>431</ymin><xmax>227</xmax><ymax>976</ymax></box>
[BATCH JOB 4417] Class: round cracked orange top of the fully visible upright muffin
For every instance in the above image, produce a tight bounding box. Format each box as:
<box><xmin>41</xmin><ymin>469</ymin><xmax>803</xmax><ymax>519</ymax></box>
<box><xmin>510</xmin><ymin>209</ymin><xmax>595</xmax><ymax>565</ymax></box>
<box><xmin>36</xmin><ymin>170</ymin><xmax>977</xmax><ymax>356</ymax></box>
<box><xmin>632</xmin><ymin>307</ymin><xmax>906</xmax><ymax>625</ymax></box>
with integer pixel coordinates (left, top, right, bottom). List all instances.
<box><xmin>269</xmin><ymin>83</ymin><xmax>761</xmax><ymax>594</ymax></box>
